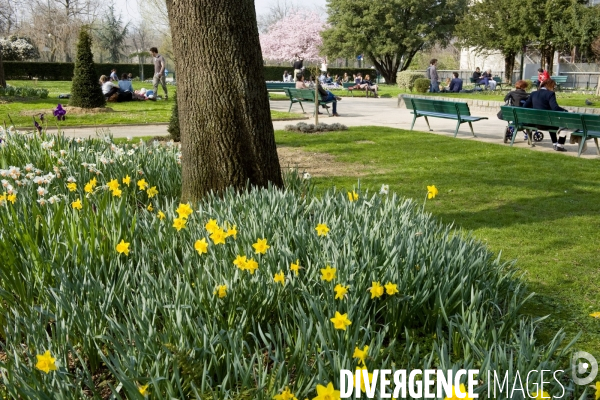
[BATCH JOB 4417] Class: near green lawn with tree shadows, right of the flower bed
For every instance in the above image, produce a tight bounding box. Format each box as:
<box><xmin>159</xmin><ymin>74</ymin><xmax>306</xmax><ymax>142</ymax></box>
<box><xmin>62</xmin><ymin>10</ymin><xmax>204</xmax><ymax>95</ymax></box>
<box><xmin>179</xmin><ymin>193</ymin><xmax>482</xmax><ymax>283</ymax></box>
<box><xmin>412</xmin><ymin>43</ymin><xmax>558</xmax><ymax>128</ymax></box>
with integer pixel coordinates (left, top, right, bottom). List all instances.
<box><xmin>276</xmin><ymin>127</ymin><xmax>600</xmax><ymax>356</ymax></box>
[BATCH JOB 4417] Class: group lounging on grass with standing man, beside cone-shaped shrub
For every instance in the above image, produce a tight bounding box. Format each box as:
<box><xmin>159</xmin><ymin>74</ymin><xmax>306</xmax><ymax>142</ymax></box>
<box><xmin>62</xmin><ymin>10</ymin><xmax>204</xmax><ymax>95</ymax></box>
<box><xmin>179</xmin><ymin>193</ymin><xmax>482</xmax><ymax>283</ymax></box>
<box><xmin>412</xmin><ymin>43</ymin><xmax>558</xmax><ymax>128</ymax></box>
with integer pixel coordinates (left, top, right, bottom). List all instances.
<box><xmin>100</xmin><ymin>47</ymin><xmax>169</xmax><ymax>102</ymax></box>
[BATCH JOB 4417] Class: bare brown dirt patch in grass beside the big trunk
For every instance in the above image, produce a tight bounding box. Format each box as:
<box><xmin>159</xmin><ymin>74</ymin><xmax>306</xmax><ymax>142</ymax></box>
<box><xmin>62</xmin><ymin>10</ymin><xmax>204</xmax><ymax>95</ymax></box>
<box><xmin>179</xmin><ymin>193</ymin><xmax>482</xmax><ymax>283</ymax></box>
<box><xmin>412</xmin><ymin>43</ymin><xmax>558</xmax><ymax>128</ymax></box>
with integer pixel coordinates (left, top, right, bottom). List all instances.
<box><xmin>277</xmin><ymin>147</ymin><xmax>387</xmax><ymax>177</ymax></box>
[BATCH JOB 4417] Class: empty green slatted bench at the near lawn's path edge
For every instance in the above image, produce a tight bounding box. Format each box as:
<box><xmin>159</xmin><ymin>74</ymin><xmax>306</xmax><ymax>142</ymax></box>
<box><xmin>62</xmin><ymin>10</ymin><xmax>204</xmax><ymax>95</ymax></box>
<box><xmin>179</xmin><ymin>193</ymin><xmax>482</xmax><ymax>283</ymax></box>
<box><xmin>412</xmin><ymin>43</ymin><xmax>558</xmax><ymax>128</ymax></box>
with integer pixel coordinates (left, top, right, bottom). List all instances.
<box><xmin>402</xmin><ymin>96</ymin><xmax>488</xmax><ymax>137</ymax></box>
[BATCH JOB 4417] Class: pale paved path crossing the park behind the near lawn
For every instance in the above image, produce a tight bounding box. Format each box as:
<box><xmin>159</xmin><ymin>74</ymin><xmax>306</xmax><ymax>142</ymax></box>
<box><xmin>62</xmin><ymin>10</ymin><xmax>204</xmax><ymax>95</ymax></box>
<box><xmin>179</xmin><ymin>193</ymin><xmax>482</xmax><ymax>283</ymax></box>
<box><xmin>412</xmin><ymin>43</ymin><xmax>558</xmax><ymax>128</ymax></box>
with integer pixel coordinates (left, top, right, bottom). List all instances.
<box><xmin>51</xmin><ymin>97</ymin><xmax>600</xmax><ymax>158</ymax></box>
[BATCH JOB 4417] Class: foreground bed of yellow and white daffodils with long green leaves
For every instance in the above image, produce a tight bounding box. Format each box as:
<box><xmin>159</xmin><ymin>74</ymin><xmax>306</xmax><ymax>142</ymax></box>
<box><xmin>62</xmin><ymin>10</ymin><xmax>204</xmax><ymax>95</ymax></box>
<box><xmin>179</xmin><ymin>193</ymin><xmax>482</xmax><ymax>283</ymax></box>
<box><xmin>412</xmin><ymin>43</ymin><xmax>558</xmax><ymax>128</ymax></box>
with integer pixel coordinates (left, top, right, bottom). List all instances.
<box><xmin>0</xmin><ymin>131</ymin><xmax>584</xmax><ymax>399</ymax></box>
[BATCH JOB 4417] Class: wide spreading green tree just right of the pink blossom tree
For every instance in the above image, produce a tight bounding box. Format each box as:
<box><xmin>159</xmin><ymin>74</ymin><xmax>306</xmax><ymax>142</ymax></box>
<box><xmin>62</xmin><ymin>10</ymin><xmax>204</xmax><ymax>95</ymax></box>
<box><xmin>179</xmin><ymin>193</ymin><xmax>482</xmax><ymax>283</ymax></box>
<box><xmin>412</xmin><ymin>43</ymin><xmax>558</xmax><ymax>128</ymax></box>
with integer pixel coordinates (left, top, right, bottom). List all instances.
<box><xmin>323</xmin><ymin>0</ymin><xmax>467</xmax><ymax>83</ymax></box>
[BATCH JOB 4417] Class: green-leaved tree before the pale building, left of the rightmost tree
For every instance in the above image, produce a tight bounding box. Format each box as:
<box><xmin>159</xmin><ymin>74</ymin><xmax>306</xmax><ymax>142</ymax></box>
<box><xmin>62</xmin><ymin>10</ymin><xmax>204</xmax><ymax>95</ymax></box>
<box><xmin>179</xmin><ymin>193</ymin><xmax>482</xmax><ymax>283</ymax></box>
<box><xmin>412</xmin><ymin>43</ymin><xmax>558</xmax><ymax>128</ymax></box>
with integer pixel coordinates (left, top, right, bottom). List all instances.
<box><xmin>456</xmin><ymin>0</ymin><xmax>535</xmax><ymax>82</ymax></box>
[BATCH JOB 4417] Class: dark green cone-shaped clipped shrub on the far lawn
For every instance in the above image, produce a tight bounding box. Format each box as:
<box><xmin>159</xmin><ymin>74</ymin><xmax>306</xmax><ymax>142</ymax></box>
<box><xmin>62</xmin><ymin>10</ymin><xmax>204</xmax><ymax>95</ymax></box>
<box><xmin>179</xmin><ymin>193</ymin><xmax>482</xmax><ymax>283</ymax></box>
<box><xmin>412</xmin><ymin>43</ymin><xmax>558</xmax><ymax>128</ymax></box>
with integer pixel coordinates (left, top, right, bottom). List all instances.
<box><xmin>69</xmin><ymin>27</ymin><xmax>106</xmax><ymax>108</ymax></box>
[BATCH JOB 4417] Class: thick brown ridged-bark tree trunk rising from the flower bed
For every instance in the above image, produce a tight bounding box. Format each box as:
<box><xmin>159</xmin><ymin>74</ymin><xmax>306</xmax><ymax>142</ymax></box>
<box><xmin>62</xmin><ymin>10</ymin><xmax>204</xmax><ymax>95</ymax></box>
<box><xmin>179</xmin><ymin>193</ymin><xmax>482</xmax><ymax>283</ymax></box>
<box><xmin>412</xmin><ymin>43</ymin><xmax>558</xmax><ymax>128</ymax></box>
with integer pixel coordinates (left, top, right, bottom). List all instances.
<box><xmin>166</xmin><ymin>0</ymin><xmax>283</xmax><ymax>202</ymax></box>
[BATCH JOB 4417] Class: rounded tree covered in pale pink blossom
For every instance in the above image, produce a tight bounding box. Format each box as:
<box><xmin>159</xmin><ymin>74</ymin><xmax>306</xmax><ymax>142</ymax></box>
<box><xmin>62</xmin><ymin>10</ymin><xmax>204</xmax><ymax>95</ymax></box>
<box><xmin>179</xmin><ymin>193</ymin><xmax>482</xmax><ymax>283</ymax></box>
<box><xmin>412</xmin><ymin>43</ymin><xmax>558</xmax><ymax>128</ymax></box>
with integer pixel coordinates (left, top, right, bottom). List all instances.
<box><xmin>260</xmin><ymin>10</ymin><xmax>328</xmax><ymax>61</ymax></box>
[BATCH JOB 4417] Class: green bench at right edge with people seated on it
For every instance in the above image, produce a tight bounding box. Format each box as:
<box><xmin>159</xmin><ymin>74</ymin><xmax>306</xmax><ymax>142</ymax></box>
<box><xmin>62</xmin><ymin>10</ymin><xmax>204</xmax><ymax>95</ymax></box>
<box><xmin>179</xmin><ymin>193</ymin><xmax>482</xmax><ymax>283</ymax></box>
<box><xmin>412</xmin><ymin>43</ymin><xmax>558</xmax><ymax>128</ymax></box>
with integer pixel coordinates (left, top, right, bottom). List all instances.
<box><xmin>500</xmin><ymin>106</ymin><xmax>600</xmax><ymax>156</ymax></box>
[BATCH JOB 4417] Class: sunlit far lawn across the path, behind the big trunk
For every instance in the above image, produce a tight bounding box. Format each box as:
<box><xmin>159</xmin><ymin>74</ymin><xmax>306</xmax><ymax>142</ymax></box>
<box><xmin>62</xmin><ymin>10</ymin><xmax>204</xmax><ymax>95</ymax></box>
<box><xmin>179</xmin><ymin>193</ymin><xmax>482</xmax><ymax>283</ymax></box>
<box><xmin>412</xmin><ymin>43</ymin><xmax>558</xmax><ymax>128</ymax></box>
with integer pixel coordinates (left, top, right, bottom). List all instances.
<box><xmin>0</xmin><ymin>81</ymin><xmax>306</xmax><ymax>129</ymax></box>
